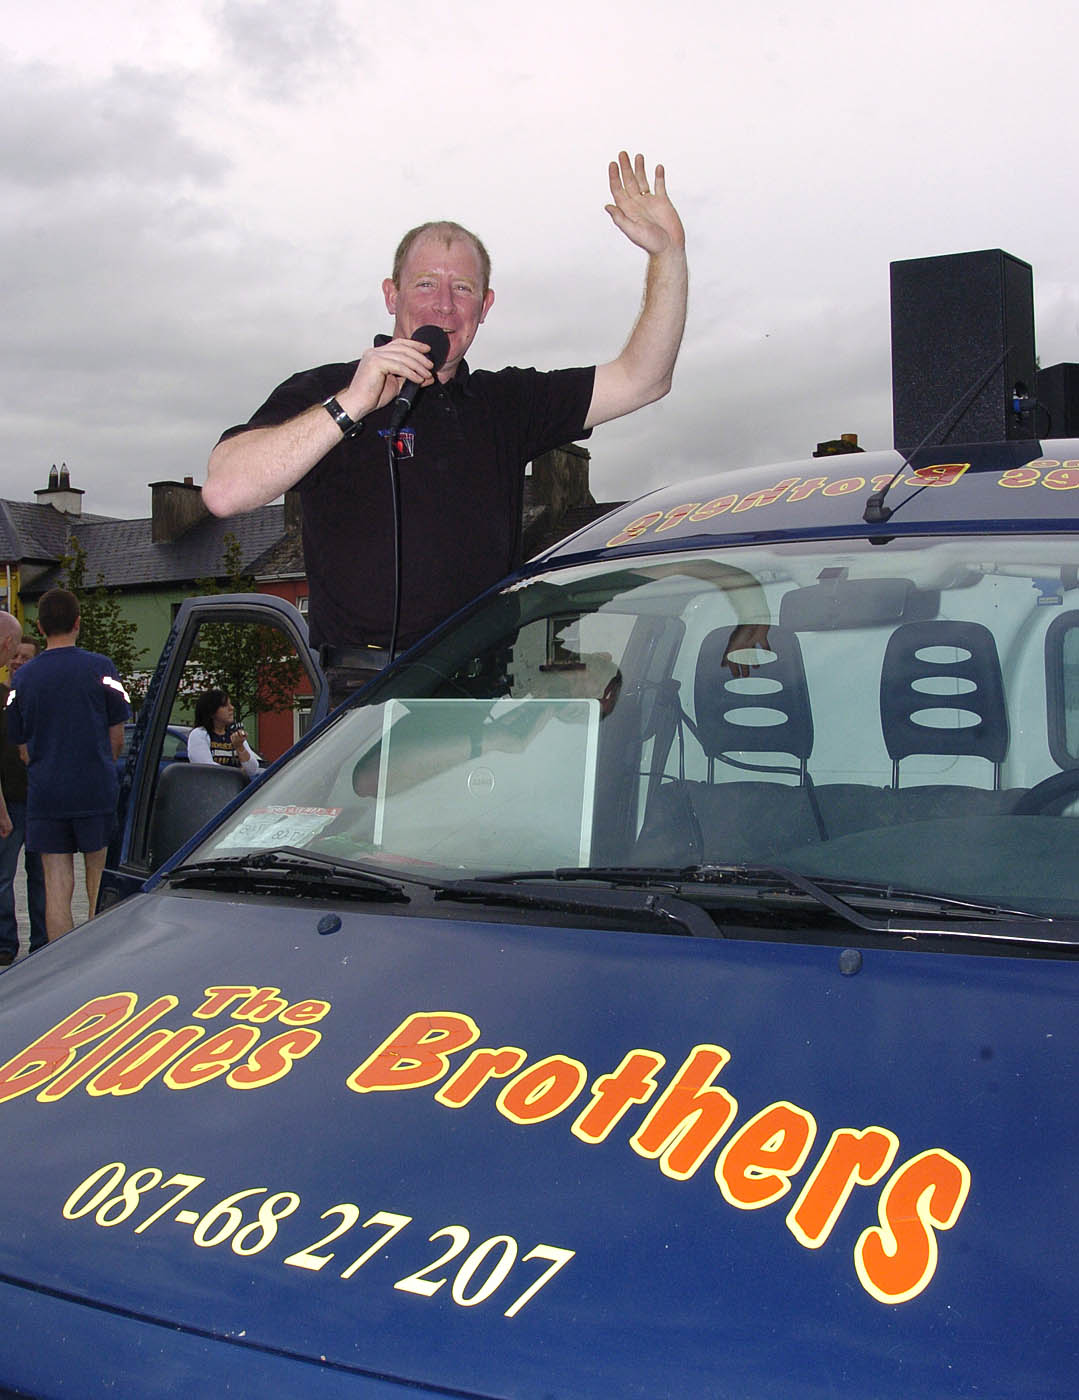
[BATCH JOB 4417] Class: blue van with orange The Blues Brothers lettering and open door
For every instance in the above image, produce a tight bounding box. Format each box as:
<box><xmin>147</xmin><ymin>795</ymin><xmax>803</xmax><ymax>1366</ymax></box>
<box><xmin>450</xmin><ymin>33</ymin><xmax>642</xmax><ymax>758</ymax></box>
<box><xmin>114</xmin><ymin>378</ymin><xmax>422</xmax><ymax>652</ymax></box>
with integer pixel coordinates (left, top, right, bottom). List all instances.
<box><xmin>0</xmin><ymin>441</ymin><xmax>1079</xmax><ymax>1400</ymax></box>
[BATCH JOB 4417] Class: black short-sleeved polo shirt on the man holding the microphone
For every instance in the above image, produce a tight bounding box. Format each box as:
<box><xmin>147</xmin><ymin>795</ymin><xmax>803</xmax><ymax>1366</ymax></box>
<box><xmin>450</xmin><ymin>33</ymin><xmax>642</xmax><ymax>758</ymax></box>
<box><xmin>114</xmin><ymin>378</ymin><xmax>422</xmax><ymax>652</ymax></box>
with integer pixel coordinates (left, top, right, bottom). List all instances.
<box><xmin>223</xmin><ymin>360</ymin><xmax>595</xmax><ymax>647</ymax></box>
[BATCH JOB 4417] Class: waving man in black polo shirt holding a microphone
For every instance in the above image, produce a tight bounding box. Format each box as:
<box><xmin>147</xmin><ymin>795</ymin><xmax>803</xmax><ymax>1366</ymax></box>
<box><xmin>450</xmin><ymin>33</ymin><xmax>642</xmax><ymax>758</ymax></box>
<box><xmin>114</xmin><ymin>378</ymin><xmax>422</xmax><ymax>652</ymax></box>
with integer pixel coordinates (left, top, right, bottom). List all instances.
<box><xmin>203</xmin><ymin>151</ymin><xmax>689</xmax><ymax>703</ymax></box>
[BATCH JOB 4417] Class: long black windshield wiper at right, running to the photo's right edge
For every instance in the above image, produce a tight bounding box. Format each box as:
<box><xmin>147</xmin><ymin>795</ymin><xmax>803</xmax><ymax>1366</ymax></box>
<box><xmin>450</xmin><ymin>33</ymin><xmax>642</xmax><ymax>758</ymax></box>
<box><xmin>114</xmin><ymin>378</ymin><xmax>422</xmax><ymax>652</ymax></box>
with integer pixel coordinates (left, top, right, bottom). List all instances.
<box><xmin>467</xmin><ymin>864</ymin><xmax>1079</xmax><ymax>945</ymax></box>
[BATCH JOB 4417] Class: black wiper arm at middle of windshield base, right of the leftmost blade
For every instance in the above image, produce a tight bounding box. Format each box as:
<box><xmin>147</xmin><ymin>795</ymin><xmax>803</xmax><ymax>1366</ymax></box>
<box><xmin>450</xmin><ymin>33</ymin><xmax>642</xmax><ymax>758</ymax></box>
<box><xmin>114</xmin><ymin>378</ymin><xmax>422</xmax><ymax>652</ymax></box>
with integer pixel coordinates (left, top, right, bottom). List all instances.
<box><xmin>434</xmin><ymin>871</ymin><xmax>724</xmax><ymax>938</ymax></box>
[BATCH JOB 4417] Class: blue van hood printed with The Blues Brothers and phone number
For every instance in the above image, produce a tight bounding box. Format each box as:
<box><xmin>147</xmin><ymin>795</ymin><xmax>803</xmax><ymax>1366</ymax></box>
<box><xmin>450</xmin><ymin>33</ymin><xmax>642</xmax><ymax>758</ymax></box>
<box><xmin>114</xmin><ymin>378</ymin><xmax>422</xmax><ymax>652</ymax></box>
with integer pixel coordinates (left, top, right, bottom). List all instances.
<box><xmin>0</xmin><ymin>890</ymin><xmax>1079</xmax><ymax>1400</ymax></box>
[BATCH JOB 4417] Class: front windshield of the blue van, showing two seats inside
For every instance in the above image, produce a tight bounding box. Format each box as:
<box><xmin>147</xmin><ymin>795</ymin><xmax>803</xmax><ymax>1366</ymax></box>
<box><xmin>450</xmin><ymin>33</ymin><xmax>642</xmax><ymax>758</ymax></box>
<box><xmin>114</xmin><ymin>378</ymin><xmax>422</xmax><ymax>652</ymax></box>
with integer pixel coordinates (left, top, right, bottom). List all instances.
<box><xmin>190</xmin><ymin>535</ymin><xmax>1079</xmax><ymax>917</ymax></box>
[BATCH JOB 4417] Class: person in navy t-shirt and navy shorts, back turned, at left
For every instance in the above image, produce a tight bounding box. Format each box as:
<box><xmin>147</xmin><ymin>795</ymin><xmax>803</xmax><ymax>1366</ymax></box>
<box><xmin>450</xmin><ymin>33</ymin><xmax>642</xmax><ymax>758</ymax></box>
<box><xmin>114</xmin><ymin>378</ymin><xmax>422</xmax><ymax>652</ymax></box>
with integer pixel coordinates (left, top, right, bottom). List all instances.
<box><xmin>7</xmin><ymin>588</ymin><xmax>132</xmax><ymax>942</ymax></box>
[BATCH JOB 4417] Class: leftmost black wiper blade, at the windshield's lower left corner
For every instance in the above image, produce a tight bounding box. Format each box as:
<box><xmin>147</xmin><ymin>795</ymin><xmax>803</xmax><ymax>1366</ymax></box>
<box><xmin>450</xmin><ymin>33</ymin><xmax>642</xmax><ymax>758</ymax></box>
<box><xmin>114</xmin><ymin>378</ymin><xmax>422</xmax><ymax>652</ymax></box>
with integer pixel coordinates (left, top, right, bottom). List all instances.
<box><xmin>162</xmin><ymin>846</ymin><xmax>409</xmax><ymax>904</ymax></box>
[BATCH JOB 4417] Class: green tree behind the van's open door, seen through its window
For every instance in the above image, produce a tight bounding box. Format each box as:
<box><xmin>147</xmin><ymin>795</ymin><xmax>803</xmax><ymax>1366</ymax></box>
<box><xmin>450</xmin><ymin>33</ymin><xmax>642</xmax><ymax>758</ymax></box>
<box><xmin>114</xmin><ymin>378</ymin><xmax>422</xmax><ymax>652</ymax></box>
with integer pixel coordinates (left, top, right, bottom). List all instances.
<box><xmin>188</xmin><ymin>533</ymin><xmax>304</xmax><ymax>722</ymax></box>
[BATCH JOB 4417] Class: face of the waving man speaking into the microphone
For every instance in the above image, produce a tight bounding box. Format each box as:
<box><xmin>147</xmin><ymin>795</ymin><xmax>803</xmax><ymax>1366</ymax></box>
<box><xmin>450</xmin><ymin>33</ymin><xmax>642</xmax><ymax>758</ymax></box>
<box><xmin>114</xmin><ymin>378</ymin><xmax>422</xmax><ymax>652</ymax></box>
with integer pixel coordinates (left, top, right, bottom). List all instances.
<box><xmin>382</xmin><ymin>234</ymin><xmax>494</xmax><ymax>384</ymax></box>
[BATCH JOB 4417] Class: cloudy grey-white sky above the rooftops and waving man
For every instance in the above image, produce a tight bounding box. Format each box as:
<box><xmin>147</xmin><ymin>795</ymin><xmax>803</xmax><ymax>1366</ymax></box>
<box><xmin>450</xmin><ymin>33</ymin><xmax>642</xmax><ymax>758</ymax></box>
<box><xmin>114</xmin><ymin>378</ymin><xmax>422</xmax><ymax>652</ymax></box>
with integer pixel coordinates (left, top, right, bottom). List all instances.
<box><xmin>0</xmin><ymin>0</ymin><xmax>1079</xmax><ymax>517</ymax></box>
